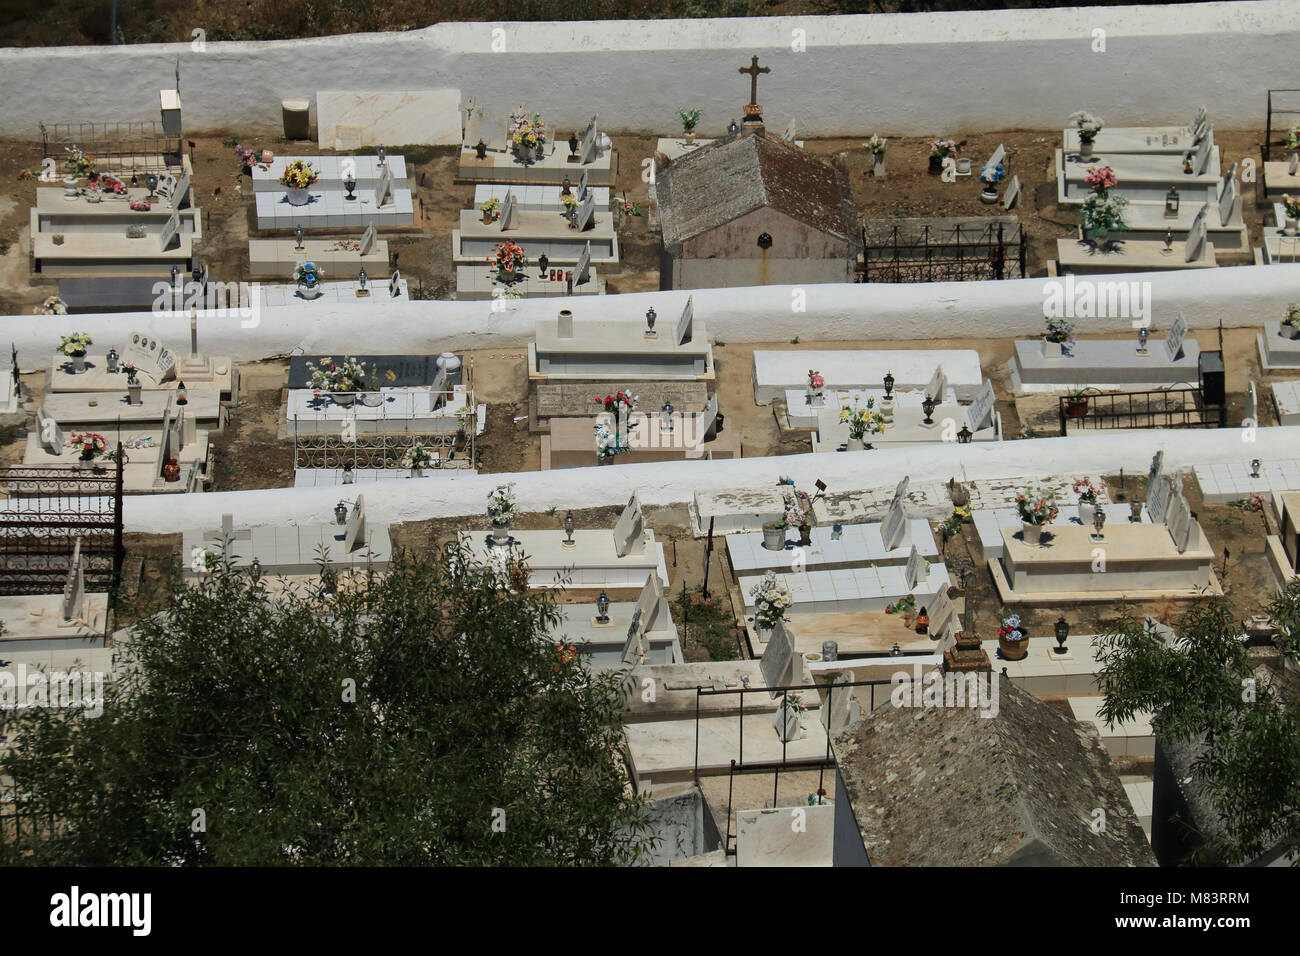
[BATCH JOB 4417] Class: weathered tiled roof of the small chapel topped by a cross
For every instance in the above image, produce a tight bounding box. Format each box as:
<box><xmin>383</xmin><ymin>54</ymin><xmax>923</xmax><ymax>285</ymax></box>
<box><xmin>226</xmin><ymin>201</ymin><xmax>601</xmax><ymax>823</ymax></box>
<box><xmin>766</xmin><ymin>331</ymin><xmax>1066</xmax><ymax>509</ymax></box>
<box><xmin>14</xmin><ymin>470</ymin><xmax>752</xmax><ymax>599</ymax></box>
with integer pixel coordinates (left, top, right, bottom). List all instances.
<box><xmin>655</xmin><ymin>133</ymin><xmax>861</xmax><ymax>247</ymax></box>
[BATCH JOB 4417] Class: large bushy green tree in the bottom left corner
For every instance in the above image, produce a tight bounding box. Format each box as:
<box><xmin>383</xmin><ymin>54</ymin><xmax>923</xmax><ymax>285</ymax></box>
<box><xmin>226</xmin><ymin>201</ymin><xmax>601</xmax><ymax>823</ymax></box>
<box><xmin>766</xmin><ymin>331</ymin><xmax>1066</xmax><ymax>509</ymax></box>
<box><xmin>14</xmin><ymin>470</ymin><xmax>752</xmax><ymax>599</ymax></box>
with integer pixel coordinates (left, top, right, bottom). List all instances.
<box><xmin>0</xmin><ymin>545</ymin><xmax>649</xmax><ymax>866</ymax></box>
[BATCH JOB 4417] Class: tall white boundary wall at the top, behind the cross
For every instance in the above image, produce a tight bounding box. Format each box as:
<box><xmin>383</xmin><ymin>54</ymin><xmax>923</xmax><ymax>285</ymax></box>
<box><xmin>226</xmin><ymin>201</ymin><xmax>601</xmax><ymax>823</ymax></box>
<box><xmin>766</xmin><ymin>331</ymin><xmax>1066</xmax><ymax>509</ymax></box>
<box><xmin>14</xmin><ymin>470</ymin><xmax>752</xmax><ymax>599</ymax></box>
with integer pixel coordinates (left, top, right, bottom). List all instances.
<box><xmin>0</xmin><ymin>0</ymin><xmax>1300</xmax><ymax>138</ymax></box>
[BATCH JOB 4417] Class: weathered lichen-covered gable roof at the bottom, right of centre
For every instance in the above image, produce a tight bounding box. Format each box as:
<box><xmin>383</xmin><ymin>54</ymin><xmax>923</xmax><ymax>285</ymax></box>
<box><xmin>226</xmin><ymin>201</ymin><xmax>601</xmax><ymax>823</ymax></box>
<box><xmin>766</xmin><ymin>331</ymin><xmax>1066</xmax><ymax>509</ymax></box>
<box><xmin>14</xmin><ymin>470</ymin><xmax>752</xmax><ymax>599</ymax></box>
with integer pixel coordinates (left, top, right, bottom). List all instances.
<box><xmin>833</xmin><ymin>679</ymin><xmax>1154</xmax><ymax>866</ymax></box>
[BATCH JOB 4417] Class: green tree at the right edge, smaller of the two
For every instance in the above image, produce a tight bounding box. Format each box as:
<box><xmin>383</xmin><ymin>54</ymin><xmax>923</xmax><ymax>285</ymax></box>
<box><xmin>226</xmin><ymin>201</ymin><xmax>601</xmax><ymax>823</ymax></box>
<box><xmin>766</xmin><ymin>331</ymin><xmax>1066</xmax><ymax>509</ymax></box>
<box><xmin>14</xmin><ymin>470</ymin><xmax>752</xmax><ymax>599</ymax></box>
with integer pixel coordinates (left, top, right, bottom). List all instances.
<box><xmin>1097</xmin><ymin>590</ymin><xmax>1300</xmax><ymax>865</ymax></box>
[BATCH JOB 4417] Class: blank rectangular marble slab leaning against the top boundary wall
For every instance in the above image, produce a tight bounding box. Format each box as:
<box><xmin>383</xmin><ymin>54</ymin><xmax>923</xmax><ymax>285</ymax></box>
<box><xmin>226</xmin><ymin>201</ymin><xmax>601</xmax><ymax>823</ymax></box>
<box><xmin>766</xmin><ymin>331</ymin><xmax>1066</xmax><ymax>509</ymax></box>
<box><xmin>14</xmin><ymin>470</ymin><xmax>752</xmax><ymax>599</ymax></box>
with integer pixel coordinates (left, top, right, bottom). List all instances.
<box><xmin>316</xmin><ymin>90</ymin><xmax>460</xmax><ymax>150</ymax></box>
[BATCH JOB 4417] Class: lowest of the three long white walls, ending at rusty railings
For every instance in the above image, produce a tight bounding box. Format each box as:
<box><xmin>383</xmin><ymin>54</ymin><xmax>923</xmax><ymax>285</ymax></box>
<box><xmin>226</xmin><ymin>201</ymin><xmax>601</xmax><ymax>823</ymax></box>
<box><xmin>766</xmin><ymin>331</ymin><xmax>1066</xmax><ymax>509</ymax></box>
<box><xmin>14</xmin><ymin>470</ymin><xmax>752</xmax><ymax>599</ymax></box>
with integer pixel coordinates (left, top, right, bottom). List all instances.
<box><xmin>125</xmin><ymin>428</ymin><xmax>1300</xmax><ymax>533</ymax></box>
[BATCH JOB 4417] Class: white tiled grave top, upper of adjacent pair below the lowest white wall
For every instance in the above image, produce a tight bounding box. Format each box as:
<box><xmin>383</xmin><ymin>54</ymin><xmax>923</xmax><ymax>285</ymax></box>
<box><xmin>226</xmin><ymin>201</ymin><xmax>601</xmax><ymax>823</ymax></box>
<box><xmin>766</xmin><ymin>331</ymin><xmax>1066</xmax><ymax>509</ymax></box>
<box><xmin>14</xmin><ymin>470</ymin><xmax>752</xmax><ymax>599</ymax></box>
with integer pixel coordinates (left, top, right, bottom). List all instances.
<box><xmin>727</xmin><ymin>518</ymin><xmax>939</xmax><ymax>575</ymax></box>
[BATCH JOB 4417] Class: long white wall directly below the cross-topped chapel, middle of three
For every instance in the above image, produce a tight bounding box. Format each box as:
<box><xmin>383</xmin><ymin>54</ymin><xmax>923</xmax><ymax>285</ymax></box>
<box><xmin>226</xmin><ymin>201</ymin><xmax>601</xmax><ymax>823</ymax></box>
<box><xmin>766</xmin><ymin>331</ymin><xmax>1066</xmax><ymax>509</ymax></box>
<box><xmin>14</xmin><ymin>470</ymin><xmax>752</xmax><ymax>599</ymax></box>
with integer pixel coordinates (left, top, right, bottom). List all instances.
<box><xmin>15</xmin><ymin>264</ymin><xmax>1300</xmax><ymax>372</ymax></box>
